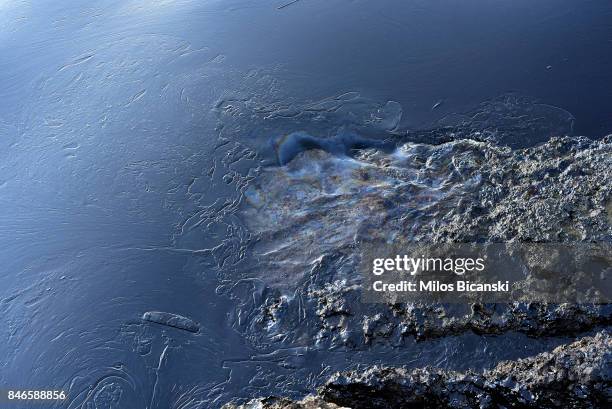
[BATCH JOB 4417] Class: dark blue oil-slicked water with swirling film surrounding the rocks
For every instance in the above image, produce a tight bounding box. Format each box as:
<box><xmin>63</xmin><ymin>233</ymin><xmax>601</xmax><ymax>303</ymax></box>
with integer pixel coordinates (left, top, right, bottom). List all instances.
<box><xmin>0</xmin><ymin>0</ymin><xmax>612</xmax><ymax>408</ymax></box>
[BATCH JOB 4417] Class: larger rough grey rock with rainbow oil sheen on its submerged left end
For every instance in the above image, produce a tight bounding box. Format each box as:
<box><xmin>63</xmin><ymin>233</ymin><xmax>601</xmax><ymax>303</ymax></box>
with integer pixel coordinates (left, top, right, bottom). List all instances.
<box><xmin>239</xmin><ymin>136</ymin><xmax>612</xmax><ymax>348</ymax></box>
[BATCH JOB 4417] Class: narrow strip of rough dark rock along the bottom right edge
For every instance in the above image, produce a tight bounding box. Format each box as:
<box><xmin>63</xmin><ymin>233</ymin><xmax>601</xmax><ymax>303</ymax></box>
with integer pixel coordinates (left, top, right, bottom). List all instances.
<box><xmin>226</xmin><ymin>331</ymin><xmax>612</xmax><ymax>409</ymax></box>
